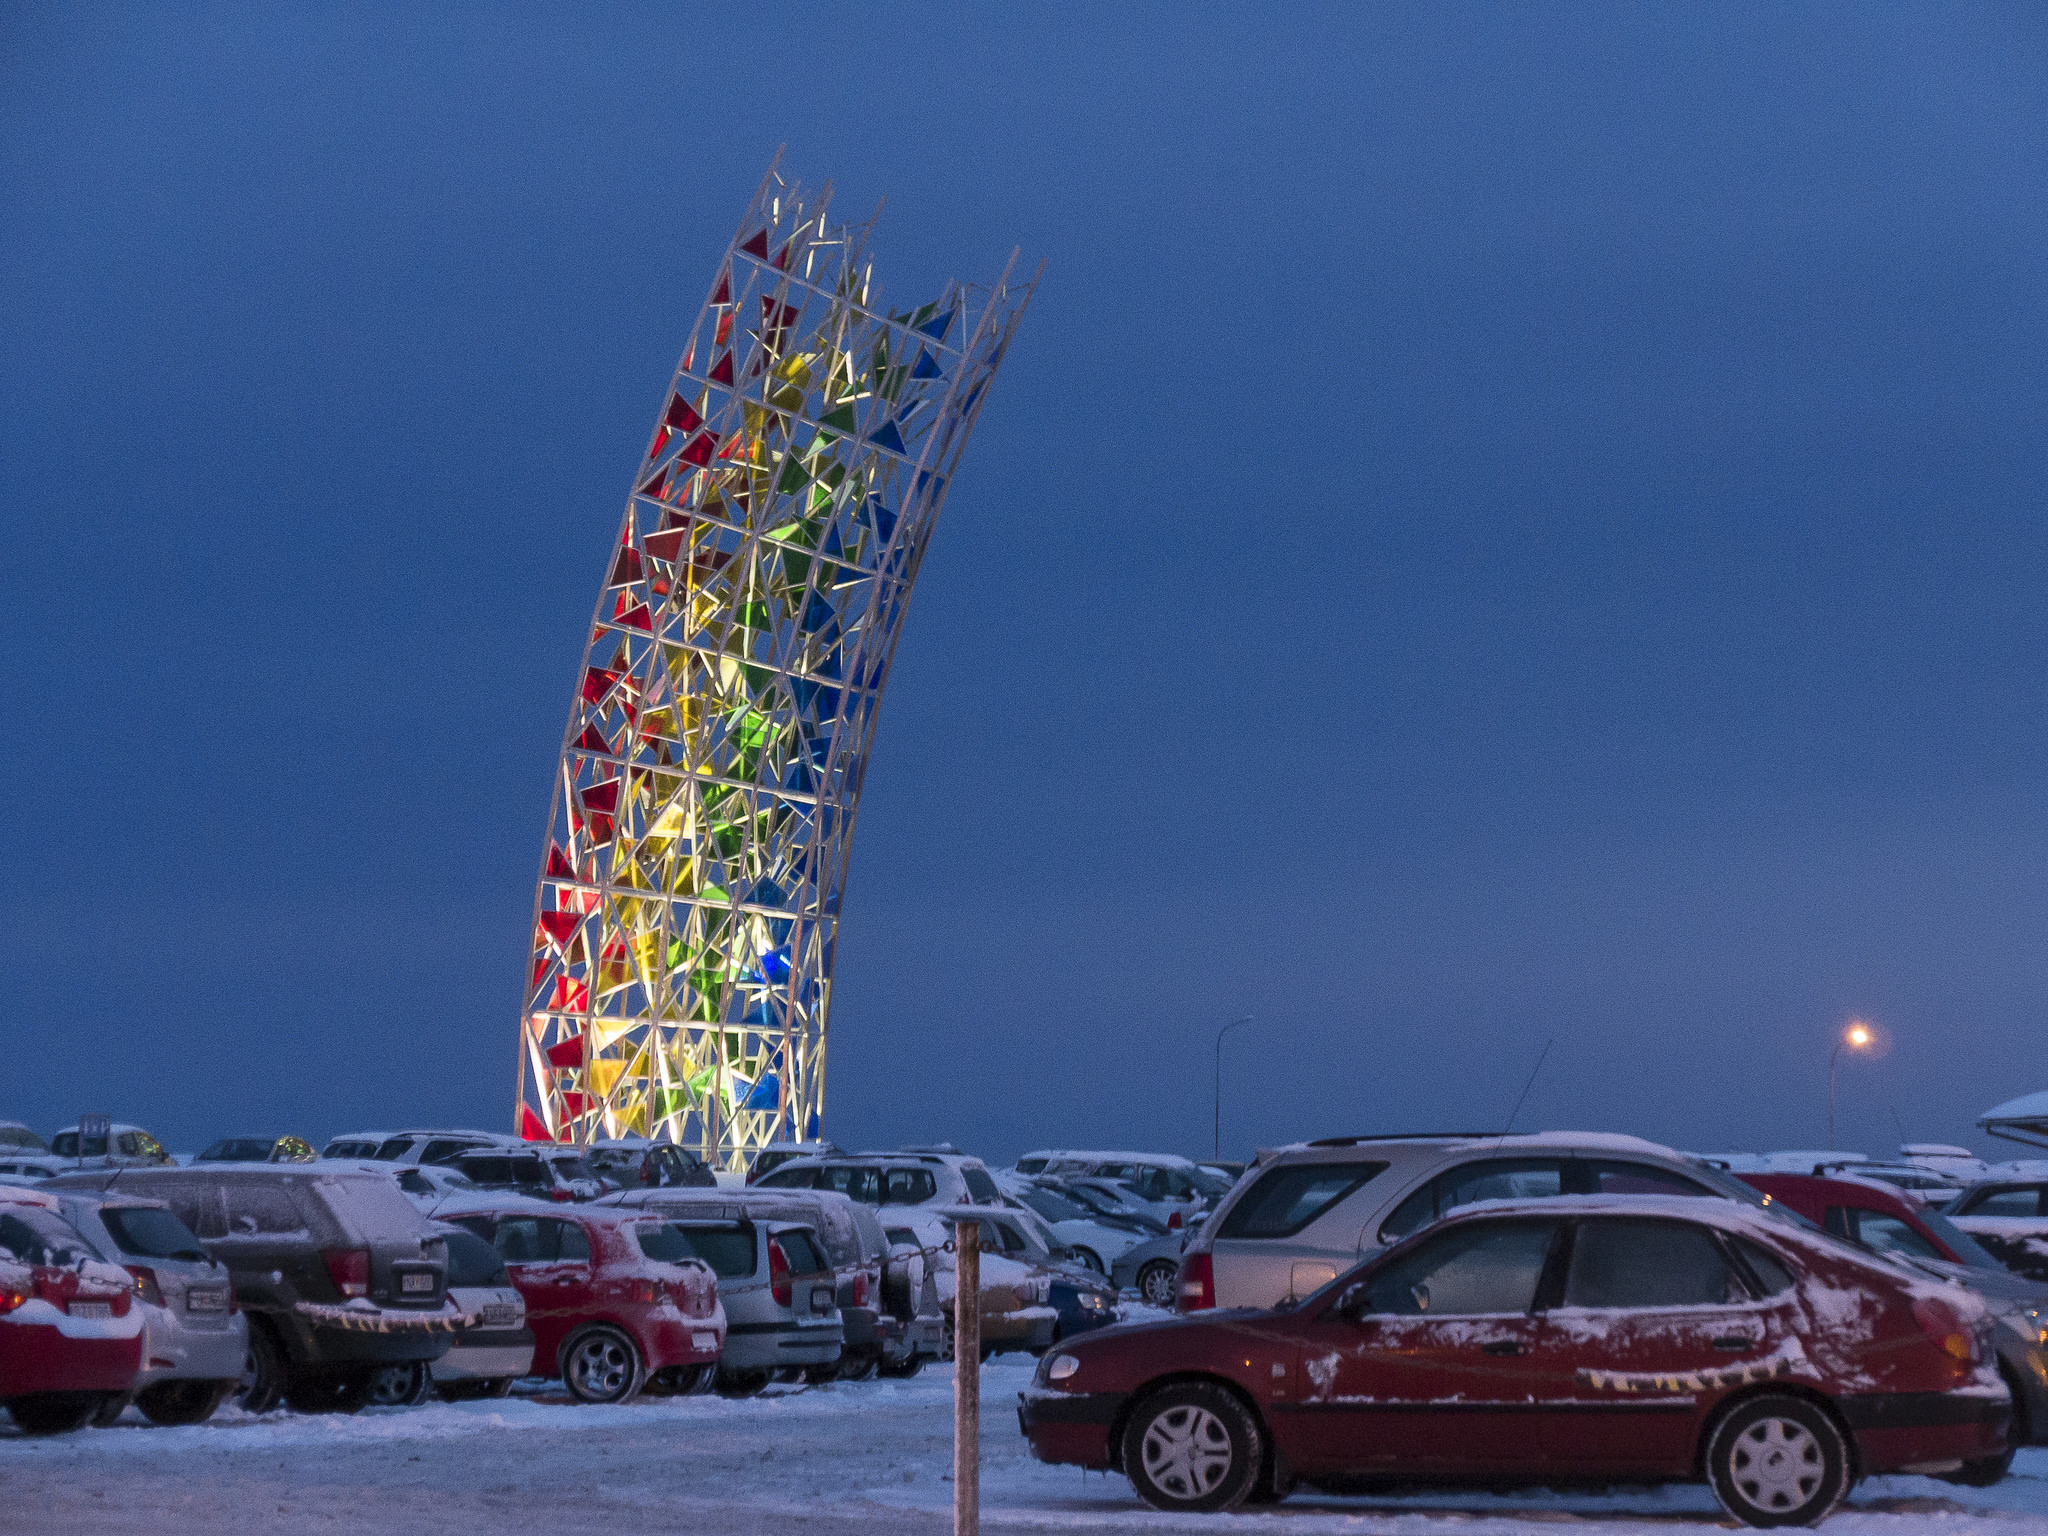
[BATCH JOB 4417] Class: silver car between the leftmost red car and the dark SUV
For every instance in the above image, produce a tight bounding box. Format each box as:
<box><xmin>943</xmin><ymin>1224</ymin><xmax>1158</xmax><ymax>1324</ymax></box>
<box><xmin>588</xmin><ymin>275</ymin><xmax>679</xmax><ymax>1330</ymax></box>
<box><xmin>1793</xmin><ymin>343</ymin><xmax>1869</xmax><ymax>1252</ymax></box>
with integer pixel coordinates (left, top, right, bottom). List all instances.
<box><xmin>51</xmin><ymin>1190</ymin><xmax>248</xmax><ymax>1423</ymax></box>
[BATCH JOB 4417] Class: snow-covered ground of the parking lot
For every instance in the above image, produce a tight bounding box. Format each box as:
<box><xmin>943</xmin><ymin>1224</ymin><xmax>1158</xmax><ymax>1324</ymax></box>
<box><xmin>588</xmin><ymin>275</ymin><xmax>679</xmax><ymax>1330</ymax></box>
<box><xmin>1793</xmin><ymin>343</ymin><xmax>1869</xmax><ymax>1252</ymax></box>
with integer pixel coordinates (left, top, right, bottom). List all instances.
<box><xmin>12</xmin><ymin>1356</ymin><xmax>2048</xmax><ymax>1536</ymax></box>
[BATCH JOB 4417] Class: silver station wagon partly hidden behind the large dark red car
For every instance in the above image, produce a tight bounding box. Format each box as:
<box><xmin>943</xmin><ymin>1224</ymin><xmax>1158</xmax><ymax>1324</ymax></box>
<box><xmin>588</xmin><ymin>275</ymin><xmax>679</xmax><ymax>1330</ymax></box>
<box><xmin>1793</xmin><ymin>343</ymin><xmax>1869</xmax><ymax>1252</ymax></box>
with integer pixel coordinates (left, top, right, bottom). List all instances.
<box><xmin>1178</xmin><ymin>1130</ymin><xmax>1763</xmax><ymax>1311</ymax></box>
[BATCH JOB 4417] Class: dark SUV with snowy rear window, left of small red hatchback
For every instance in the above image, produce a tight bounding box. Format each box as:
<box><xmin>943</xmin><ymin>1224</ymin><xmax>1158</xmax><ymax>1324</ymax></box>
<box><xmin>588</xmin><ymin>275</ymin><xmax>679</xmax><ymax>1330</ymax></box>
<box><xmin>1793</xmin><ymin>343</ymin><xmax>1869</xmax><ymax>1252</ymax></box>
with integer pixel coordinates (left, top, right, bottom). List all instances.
<box><xmin>45</xmin><ymin>1163</ymin><xmax>457</xmax><ymax>1413</ymax></box>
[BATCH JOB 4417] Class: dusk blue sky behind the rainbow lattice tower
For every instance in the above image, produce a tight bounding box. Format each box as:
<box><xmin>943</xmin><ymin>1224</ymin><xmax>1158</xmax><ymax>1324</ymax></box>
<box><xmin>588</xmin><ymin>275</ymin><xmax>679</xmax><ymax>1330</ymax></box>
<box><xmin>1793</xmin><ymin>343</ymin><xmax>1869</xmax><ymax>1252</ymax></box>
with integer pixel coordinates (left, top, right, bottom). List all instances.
<box><xmin>12</xmin><ymin>2</ymin><xmax>2048</xmax><ymax>1161</ymax></box>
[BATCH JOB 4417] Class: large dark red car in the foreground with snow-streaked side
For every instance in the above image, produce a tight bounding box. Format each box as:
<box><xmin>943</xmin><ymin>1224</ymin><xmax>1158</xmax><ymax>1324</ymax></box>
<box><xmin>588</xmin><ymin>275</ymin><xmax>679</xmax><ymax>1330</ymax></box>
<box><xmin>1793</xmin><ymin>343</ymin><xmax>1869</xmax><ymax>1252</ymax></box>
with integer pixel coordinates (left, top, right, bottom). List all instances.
<box><xmin>1020</xmin><ymin>1196</ymin><xmax>2011</xmax><ymax>1526</ymax></box>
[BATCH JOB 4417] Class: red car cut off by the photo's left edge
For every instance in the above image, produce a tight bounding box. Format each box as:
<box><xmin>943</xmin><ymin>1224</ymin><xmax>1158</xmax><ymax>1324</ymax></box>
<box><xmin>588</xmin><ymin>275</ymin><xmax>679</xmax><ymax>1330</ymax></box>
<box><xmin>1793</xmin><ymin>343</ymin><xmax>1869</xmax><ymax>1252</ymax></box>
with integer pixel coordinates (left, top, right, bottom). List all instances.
<box><xmin>0</xmin><ymin>1190</ymin><xmax>143</xmax><ymax>1434</ymax></box>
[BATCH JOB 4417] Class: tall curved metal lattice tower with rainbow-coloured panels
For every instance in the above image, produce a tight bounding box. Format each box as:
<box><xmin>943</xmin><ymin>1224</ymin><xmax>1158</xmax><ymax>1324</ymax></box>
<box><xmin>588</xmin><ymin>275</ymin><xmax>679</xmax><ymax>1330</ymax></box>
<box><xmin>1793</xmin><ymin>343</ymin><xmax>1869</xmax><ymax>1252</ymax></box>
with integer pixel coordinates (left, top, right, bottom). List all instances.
<box><xmin>518</xmin><ymin>170</ymin><xmax>1036</xmax><ymax>1167</ymax></box>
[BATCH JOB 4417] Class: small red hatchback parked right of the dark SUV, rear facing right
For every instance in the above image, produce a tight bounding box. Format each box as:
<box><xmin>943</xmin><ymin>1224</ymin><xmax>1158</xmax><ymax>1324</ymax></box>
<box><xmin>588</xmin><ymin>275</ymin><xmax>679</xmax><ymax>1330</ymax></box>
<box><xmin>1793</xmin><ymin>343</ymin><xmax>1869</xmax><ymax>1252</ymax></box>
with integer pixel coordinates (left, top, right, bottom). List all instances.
<box><xmin>436</xmin><ymin>1202</ymin><xmax>725</xmax><ymax>1403</ymax></box>
